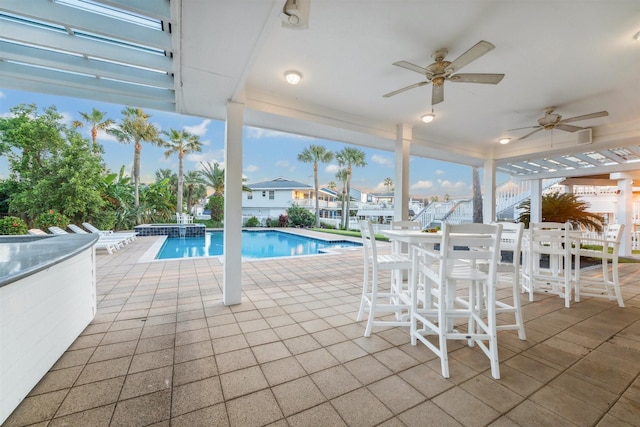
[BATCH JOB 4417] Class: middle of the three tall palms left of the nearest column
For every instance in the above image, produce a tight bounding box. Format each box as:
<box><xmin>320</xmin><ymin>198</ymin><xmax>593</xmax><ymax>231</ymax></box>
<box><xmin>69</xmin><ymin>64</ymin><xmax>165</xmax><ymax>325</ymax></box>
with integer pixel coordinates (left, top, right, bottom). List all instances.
<box><xmin>107</xmin><ymin>107</ymin><xmax>162</xmax><ymax>208</ymax></box>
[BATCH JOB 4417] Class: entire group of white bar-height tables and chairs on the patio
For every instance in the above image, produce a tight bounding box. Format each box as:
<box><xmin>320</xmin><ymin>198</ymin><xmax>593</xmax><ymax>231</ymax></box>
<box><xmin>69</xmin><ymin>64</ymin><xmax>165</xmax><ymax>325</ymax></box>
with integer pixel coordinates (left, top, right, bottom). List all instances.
<box><xmin>357</xmin><ymin>221</ymin><xmax>624</xmax><ymax>379</ymax></box>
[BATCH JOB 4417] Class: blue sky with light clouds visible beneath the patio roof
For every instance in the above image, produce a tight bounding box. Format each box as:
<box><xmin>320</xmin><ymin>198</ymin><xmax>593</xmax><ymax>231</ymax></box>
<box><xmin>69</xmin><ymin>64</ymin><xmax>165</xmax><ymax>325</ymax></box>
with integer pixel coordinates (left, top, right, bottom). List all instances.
<box><xmin>0</xmin><ymin>88</ymin><xmax>484</xmax><ymax>198</ymax></box>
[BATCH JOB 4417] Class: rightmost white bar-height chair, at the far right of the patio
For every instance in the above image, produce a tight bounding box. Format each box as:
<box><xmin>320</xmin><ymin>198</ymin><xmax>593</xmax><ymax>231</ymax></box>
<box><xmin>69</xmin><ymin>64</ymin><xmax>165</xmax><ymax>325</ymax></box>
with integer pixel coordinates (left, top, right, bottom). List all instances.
<box><xmin>575</xmin><ymin>224</ymin><xmax>624</xmax><ymax>307</ymax></box>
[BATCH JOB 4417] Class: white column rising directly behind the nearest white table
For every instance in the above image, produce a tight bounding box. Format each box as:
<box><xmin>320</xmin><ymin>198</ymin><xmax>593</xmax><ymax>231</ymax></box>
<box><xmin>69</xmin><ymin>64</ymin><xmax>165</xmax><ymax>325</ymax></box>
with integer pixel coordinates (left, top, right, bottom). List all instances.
<box><xmin>393</xmin><ymin>124</ymin><xmax>413</xmax><ymax>221</ymax></box>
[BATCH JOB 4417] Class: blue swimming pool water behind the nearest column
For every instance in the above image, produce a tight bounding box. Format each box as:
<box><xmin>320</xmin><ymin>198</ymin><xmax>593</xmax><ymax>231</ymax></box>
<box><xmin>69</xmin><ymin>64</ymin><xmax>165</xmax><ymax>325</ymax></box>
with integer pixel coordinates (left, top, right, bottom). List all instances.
<box><xmin>156</xmin><ymin>230</ymin><xmax>361</xmax><ymax>259</ymax></box>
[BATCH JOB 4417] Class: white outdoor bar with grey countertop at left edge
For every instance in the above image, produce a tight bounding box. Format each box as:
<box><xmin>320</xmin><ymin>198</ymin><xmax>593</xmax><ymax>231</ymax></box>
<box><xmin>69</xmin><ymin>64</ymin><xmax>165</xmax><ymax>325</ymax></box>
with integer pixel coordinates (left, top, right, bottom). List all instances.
<box><xmin>0</xmin><ymin>234</ymin><xmax>98</xmax><ymax>422</ymax></box>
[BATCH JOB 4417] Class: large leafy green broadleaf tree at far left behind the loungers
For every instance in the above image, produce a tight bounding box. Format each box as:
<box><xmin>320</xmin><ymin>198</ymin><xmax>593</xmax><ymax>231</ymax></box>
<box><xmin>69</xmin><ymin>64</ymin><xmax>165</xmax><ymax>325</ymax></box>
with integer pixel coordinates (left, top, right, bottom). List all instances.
<box><xmin>0</xmin><ymin>104</ymin><xmax>104</xmax><ymax>224</ymax></box>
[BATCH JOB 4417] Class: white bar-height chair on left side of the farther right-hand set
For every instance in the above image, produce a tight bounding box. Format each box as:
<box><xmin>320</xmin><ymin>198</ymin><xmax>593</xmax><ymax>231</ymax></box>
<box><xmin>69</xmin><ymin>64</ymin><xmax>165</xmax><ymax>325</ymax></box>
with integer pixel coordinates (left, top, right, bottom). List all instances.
<box><xmin>522</xmin><ymin>222</ymin><xmax>574</xmax><ymax>308</ymax></box>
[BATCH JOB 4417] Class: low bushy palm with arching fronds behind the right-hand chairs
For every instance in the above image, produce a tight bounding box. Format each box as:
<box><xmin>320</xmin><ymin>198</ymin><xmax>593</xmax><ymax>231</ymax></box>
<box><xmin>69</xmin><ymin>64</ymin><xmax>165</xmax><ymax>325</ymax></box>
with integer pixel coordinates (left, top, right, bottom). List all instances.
<box><xmin>518</xmin><ymin>192</ymin><xmax>604</xmax><ymax>231</ymax></box>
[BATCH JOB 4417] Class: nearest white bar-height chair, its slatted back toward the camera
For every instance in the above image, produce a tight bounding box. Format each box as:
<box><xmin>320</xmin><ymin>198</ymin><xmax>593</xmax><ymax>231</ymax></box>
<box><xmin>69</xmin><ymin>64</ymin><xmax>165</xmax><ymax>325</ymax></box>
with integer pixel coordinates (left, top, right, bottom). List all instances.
<box><xmin>411</xmin><ymin>224</ymin><xmax>502</xmax><ymax>379</ymax></box>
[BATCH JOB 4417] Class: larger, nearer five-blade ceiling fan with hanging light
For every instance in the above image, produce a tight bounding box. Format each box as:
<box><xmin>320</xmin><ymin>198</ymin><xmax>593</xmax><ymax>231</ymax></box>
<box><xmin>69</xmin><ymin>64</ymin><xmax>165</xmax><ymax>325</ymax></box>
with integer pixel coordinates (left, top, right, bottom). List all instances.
<box><xmin>383</xmin><ymin>40</ymin><xmax>504</xmax><ymax>105</ymax></box>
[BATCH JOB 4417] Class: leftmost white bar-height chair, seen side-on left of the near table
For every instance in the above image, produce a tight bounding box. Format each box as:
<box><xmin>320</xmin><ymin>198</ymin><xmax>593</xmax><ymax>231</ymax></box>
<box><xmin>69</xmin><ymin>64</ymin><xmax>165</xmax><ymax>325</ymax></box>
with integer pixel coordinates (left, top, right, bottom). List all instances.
<box><xmin>356</xmin><ymin>221</ymin><xmax>411</xmax><ymax>337</ymax></box>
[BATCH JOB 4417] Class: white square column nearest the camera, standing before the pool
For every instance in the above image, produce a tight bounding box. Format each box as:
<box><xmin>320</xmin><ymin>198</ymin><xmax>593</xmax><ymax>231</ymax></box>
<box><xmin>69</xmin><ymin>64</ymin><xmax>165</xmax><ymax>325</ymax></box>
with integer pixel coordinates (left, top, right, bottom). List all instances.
<box><xmin>222</xmin><ymin>102</ymin><xmax>244</xmax><ymax>305</ymax></box>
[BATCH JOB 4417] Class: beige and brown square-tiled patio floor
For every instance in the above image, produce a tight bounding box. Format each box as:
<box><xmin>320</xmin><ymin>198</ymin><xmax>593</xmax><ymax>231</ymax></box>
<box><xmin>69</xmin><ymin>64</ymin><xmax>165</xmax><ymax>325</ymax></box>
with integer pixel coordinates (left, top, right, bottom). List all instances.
<box><xmin>4</xmin><ymin>237</ymin><xmax>640</xmax><ymax>427</ymax></box>
